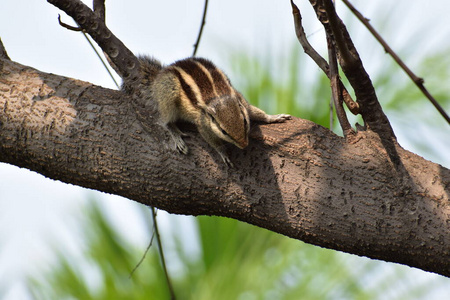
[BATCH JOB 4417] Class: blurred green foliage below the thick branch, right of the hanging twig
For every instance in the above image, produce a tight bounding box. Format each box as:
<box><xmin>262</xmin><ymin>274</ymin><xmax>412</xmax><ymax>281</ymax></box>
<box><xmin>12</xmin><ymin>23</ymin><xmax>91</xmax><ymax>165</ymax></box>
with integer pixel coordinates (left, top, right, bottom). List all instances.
<box><xmin>181</xmin><ymin>217</ymin><xmax>372</xmax><ymax>300</ymax></box>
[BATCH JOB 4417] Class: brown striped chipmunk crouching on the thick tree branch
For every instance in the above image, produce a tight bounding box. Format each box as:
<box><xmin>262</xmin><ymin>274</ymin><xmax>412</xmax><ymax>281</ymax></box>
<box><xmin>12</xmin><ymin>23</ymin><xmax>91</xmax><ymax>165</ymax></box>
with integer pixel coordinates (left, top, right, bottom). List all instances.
<box><xmin>130</xmin><ymin>56</ymin><xmax>291</xmax><ymax>167</ymax></box>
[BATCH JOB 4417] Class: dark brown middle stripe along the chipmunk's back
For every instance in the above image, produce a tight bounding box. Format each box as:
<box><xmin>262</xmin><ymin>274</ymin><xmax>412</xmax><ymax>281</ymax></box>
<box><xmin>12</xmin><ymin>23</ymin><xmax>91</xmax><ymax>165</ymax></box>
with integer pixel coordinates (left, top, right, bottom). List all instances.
<box><xmin>174</xmin><ymin>59</ymin><xmax>217</xmax><ymax>104</ymax></box>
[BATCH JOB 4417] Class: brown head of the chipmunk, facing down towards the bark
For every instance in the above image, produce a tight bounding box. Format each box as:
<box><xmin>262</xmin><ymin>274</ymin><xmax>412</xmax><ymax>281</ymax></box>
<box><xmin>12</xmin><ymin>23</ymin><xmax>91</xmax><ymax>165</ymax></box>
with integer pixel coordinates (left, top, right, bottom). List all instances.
<box><xmin>205</xmin><ymin>93</ymin><xmax>250</xmax><ymax>149</ymax></box>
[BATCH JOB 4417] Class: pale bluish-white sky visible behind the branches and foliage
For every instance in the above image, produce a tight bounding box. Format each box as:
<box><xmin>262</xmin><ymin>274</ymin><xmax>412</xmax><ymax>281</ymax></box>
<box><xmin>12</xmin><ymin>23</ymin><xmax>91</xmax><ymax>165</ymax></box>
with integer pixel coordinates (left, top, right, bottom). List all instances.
<box><xmin>0</xmin><ymin>0</ymin><xmax>450</xmax><ymax>300</ymax></box>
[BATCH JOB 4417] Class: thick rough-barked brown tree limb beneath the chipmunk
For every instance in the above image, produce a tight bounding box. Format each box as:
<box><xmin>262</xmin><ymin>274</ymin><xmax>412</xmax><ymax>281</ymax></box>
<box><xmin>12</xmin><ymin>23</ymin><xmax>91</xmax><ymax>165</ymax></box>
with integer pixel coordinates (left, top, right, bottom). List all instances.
<box><xmin>0</xmin><ymin>59</ymin><xmax>450</xmax><ymax>276</ymax></box>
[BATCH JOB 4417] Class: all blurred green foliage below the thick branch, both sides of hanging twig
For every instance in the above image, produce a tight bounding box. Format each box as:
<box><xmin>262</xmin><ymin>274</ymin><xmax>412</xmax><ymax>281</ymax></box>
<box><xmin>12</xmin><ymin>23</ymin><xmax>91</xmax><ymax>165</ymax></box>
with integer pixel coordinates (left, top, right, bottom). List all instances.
<box><xmin>30</xmin><ymin>201</ymin><xmax>373</xmax><ymax>300</ymax></box>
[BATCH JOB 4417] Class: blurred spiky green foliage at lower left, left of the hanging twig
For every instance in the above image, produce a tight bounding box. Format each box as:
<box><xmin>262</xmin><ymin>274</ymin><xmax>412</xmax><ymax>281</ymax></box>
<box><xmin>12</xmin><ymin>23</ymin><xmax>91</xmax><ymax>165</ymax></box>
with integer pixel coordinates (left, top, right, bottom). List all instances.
<box><xmin>30</xmin><ymin>200</ymin><xmax>169</xmax><ymax>300</ymax></box>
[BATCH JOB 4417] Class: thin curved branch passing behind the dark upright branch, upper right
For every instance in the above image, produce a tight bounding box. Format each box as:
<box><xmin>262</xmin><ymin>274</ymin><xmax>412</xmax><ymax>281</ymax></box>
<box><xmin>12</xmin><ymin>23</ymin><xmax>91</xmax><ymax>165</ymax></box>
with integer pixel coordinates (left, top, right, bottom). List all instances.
<box><xmin>291</xmin><ymin>0</ymin><xmax>359</xmax><ymax>115</ymax></box>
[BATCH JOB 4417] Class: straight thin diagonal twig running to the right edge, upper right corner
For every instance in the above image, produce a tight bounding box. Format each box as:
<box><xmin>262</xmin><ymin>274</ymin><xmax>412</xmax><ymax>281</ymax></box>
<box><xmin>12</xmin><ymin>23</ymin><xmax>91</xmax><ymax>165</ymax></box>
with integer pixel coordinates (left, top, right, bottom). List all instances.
<box><xmin>342</xmin><ymin>0</ymin><xmax>450</xmax><ymax>124</ymax></box>
